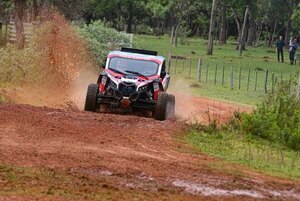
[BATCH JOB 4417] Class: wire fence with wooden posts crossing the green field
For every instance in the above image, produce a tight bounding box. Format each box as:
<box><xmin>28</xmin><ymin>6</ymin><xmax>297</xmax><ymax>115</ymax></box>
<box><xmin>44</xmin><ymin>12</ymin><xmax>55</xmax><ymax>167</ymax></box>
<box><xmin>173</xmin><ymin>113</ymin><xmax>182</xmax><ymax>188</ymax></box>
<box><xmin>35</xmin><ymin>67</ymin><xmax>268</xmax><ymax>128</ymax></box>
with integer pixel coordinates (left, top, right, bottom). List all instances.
<box><xmin>168</xmin><ymin>53</ymin><xmax>300</xmax><ymax>96</ymax></box>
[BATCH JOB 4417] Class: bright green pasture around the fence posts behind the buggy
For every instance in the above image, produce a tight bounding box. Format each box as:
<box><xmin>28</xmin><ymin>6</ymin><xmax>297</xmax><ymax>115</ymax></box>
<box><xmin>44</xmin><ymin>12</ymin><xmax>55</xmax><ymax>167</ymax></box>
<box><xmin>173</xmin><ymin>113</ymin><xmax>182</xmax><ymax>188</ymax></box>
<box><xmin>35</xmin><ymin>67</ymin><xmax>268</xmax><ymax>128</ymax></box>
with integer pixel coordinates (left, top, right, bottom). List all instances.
<box><xmin>134</xmin><ymin>35</ymin><xmax>300</xmax><ymax>105</ymax></box>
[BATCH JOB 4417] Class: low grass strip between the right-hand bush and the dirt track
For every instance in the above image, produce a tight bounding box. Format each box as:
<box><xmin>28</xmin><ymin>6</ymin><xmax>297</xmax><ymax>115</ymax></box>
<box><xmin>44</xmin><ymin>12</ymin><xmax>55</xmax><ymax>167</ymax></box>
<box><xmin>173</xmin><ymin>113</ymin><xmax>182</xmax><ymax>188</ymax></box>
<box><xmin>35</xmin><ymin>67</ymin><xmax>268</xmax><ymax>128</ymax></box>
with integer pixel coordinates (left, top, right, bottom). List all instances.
<box><xmin>185</xmin><ymin>129</ymin><xmax>300</xmax><ymax>180</ymax></box>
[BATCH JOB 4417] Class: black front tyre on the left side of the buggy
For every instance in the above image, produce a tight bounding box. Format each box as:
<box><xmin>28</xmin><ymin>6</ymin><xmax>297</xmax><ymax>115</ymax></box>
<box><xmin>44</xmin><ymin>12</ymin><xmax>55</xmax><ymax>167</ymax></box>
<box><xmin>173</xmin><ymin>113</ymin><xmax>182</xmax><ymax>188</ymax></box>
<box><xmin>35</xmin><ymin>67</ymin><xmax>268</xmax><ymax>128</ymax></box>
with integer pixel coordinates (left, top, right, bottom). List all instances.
<box><xmin>84</xmin><ymin>84</ymin><xmax>99</xmax><ymax>112</ymax></box>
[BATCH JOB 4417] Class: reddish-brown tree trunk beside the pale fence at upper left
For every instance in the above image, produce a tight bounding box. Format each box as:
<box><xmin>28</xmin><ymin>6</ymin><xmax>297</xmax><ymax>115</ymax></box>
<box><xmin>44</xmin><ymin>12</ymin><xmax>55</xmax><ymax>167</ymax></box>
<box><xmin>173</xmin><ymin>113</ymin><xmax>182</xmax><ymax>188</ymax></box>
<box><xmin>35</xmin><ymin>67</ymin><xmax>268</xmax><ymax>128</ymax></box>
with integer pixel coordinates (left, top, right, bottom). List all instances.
<box><xmin>14</xmin><ymin>0</ymin><xmax>26</xmax><ymax>49</ymax></box>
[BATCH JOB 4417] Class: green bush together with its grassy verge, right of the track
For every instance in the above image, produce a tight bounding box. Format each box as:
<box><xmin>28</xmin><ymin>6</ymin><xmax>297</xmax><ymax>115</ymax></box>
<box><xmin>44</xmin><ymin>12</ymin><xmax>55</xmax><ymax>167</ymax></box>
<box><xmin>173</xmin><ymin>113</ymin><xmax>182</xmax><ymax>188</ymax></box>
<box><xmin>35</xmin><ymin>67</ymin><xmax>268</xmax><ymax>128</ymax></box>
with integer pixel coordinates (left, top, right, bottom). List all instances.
<box><xmin>185</xmin><ymin>82</ymin><xmax>300</xmax><ymax>179</ymax></box>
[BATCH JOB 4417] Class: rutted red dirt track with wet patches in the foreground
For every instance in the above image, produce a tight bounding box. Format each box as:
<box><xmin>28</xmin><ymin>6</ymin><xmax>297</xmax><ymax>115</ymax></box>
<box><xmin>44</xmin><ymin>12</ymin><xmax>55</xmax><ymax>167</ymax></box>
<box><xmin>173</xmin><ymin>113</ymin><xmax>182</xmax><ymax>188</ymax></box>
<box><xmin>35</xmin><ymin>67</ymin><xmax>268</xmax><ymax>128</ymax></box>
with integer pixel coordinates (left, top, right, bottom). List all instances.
<box><xmin>0</xmin><ymin>99</ymin><xmax>300</xmax><ymax>200</ymax></box>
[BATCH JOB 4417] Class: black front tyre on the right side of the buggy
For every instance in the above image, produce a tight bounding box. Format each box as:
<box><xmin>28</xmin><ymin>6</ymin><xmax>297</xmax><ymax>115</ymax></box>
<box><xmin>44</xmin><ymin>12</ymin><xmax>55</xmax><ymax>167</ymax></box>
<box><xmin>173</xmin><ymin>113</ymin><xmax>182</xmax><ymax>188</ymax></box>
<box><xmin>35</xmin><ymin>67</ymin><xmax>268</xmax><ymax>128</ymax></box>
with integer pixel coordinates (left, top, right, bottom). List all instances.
<box><xmin>154</xmin><ymin>92</ymin><xmax>169</xmax><ymax>121</ymax></box>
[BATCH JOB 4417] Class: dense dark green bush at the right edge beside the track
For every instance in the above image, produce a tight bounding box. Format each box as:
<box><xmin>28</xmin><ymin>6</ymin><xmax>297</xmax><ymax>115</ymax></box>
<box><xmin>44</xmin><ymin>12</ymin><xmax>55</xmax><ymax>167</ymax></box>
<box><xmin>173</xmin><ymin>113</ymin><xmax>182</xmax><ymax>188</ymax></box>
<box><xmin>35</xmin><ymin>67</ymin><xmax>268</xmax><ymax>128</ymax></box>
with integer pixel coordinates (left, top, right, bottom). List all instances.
<box><xmin>242</xmin><ymin>82</ymin><xmax>300</xmax><ymax>150</ymax></box>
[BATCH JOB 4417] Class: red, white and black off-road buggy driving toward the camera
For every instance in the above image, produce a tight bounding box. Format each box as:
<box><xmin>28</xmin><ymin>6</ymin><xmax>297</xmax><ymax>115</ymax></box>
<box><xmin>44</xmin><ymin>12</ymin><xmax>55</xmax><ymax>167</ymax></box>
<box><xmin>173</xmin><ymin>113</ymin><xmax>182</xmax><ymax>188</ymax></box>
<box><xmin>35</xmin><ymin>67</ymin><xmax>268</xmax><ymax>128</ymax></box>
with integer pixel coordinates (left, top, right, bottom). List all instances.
<box><xmin>85</xmin><ymin>48</ymin><xmax>175</xmax><ymax>120</ymax></box>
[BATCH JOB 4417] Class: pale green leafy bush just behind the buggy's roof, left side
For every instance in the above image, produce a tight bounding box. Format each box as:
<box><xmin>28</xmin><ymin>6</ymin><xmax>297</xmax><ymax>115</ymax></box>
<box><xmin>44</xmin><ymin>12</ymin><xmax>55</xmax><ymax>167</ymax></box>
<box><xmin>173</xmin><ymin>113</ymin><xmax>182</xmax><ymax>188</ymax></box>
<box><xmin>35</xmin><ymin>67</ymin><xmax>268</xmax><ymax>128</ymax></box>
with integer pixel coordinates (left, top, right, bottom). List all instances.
<box><xmin>78</xmin><ymin>20</ymin><xmax>131</xmax><ymax>64</ymax></box>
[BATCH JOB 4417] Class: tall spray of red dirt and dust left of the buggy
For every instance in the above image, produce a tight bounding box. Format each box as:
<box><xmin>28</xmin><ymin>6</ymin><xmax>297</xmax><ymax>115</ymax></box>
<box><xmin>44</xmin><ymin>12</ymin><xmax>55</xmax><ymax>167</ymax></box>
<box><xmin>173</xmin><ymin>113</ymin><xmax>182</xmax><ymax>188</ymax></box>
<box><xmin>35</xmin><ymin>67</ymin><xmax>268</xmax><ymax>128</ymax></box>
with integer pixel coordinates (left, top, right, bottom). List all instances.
<box><xmin>3</xmin><ymin>10</ymin><xmax>99</xmax><ymax>110</ymax></box>
